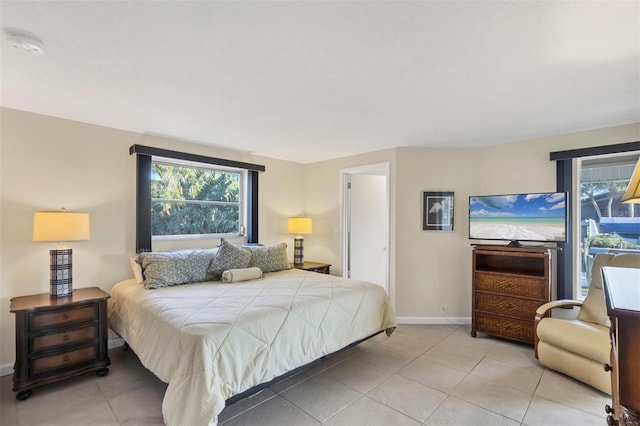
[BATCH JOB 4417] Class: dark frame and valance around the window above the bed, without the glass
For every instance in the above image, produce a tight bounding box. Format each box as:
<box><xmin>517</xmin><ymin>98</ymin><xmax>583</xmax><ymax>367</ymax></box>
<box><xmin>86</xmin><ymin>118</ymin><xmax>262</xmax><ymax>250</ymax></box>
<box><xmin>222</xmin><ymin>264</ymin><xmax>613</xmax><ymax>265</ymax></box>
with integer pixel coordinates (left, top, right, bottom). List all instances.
<box><xmin>129</xmin><ymin>145</ymin><xmax>265</xmax><ymax>253</ymax></box>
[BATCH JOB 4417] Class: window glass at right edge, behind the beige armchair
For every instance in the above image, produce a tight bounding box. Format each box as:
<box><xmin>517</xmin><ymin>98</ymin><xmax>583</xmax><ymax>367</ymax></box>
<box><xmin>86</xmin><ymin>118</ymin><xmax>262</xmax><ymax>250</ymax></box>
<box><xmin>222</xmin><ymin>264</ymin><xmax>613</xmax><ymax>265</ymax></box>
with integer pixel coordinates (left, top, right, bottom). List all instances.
<box><xmin>575</xmin><ymin>153</ymin><xmax>640</xmax><ymax>299</ymax></box>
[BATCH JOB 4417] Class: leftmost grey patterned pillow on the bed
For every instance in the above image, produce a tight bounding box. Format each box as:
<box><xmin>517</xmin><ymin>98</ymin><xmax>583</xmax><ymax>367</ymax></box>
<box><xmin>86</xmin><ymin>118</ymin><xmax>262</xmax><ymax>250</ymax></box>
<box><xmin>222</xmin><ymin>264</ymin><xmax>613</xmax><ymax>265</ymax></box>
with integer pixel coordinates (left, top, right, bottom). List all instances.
<box><xmin>137</xmin><ymin>250</ymin><xmax>213</xmax><ymax>289</ymax></box>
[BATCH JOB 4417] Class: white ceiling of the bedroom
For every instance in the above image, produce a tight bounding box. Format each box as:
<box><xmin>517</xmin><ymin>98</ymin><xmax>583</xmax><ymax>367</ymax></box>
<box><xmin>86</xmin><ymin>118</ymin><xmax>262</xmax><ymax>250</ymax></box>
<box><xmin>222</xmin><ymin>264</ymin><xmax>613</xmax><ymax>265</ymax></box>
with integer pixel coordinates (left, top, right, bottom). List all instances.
<box><xmin>0</xmin><ymin>0</ymin><xmax>640</xmax><ymax>163</ymax></box>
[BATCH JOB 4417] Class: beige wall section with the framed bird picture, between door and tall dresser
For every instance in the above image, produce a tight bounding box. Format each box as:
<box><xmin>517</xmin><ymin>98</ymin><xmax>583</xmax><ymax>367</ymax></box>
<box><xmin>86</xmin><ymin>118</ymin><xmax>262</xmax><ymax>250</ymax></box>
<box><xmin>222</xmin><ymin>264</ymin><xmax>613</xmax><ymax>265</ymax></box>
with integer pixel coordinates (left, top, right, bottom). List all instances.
<box><xmin>395</xmin><ymin>148</ymin><xmax>480</xmax><ymax>322</ymax></box>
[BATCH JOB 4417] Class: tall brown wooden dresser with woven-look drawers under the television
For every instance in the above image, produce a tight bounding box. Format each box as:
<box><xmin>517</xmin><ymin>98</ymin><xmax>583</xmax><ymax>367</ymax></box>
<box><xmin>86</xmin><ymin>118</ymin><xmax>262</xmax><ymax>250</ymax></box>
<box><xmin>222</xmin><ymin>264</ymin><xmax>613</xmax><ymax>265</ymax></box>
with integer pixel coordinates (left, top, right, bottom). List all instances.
<box><xmin>471</xmin><ymin>245</ymin><xmax>551</xmax><ymax>345</ymax></box>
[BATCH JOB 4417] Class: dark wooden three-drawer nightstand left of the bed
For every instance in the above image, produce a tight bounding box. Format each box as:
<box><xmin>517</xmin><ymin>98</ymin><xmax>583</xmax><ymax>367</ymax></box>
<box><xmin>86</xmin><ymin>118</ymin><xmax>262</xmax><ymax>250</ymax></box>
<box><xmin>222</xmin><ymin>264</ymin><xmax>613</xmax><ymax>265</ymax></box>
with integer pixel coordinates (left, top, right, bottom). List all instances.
<box><xmin>11</xmin><ymin>287</ymin><xmax>110</xmax><ymax>400</ymax></box>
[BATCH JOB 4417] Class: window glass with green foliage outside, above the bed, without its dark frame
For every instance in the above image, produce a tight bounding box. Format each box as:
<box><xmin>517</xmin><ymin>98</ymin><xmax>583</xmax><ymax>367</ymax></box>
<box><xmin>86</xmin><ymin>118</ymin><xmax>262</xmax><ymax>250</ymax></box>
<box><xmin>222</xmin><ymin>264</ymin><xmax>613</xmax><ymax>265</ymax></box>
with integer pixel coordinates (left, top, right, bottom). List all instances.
<box><xmin>151</xmin><ymin>158</ymin><xmax>246</xmax><ymax>239</ymax></box>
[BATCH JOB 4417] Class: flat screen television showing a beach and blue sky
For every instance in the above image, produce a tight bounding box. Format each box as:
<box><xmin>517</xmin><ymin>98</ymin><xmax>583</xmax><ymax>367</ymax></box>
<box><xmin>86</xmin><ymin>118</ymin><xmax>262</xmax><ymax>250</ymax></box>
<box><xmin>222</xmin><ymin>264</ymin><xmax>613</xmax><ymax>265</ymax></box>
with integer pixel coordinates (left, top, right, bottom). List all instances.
<box><xmin>469</xmin><ymin>192</ymin><xmax>567</xmax><ymax>246</ymax></box>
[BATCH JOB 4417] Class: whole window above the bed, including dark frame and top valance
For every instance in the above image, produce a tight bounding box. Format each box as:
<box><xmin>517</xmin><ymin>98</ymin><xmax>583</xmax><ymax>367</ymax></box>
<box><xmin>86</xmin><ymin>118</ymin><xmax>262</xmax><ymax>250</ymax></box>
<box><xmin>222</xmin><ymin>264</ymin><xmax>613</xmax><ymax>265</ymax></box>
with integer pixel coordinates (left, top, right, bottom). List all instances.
<box><xmin>129</xmin><ymin>145</ymin><xmax>265</xmax><ymax>253</ymax></box>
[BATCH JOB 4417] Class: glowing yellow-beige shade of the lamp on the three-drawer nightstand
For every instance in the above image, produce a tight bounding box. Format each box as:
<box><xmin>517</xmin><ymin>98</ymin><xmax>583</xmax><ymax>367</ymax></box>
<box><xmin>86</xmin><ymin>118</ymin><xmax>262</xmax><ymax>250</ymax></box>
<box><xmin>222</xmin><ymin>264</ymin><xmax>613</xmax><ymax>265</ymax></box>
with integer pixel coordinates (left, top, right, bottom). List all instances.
<box><xmin>33</xmin><ymin>211</ymin><xmax>90</xmax><ymax>242</ymax></box>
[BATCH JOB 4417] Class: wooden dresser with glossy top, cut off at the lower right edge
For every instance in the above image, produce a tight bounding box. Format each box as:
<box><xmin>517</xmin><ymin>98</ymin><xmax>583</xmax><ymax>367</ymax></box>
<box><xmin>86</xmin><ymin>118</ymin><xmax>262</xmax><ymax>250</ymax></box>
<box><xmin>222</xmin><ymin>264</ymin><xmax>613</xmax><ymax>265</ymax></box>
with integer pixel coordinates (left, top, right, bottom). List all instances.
<box><xmin>602</xmin><ymin>266</ymin><xmax>640</xmax><ymax>426</ymax></box>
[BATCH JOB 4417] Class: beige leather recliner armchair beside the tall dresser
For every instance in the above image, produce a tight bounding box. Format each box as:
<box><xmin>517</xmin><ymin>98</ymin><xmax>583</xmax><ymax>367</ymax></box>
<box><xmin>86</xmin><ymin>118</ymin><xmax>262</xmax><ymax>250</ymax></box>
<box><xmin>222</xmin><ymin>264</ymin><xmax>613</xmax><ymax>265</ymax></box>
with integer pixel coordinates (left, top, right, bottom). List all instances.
<box><xmin>534</xmin><ymin>253</ymin><xmax>640</xmax><ymax>394</ymax></box>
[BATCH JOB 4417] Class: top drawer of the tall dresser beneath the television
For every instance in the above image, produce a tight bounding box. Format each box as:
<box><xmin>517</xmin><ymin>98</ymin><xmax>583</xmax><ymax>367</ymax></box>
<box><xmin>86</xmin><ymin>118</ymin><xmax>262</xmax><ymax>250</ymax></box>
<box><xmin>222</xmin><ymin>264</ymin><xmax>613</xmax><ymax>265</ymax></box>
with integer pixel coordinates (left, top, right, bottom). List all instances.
<box><xmin>475</xmin><ymin>272</ymin><xmax>545</xmax><ymax>299</ymax></box>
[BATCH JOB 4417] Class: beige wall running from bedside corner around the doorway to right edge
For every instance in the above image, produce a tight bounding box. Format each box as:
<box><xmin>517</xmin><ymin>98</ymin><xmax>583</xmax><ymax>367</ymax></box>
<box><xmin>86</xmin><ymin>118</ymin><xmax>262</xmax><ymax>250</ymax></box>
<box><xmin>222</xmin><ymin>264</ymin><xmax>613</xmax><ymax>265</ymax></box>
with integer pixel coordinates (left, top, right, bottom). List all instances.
<box><xmin>305</xmin><ymin>124</ymin><xmax>640</xmax><ymax>322</ymax></box>
